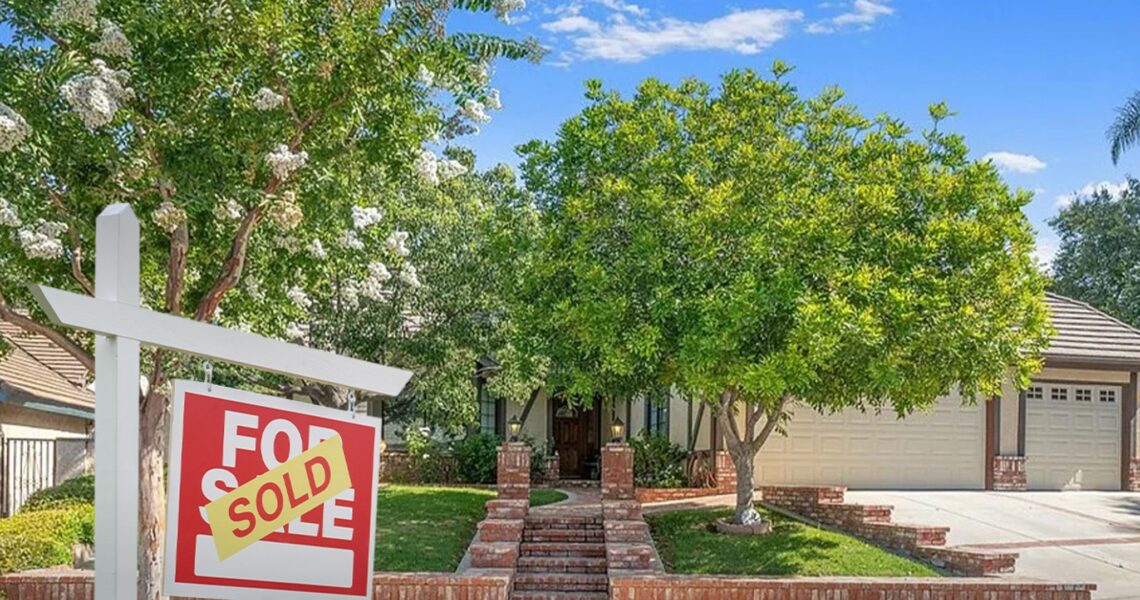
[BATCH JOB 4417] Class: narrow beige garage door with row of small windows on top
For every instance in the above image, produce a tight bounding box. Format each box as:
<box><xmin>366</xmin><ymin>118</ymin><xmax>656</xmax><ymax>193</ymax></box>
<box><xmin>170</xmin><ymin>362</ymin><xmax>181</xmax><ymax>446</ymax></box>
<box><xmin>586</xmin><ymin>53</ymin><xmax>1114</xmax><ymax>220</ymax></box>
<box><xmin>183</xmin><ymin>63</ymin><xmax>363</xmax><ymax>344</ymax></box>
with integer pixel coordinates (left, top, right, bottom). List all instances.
<box><xmin>1025</xmin><ymin>383</ymin><xmax>1122</xmax><ymax>489</ymax></box>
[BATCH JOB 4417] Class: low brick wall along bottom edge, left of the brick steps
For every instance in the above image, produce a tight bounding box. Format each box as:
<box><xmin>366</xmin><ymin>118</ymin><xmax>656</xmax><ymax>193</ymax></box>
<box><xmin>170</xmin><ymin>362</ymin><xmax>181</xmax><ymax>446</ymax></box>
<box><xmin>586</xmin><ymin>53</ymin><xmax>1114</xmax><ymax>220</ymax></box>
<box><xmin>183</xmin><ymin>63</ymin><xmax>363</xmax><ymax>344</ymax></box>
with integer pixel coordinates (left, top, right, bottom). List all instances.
<box><xmin>0</xmin><ymin>569</ymin><xmax>511</xmax><ymax>600</ymax></box>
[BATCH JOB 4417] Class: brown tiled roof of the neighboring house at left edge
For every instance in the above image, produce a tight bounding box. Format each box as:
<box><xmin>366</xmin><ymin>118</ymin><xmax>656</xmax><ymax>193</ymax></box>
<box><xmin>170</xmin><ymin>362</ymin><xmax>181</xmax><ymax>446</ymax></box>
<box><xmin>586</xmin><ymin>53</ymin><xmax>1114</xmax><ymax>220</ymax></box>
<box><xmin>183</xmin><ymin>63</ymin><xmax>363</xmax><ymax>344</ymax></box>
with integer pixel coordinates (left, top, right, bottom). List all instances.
<box><xmin>0</xmin><ymin>321</ymin><xmax>95</xmax><ymax>419</ymax></box>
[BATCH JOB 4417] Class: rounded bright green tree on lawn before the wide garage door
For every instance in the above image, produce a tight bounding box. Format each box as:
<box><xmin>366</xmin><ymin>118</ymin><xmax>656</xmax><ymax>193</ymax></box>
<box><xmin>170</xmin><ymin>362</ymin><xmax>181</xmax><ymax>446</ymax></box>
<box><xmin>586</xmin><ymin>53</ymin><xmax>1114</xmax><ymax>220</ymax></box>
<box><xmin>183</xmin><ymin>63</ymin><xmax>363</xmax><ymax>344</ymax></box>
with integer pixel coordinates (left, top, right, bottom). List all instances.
<box><xmin>522</xmin><ymin>63</ymin><xmax>1049</xmax><ymax>524</ymax></box>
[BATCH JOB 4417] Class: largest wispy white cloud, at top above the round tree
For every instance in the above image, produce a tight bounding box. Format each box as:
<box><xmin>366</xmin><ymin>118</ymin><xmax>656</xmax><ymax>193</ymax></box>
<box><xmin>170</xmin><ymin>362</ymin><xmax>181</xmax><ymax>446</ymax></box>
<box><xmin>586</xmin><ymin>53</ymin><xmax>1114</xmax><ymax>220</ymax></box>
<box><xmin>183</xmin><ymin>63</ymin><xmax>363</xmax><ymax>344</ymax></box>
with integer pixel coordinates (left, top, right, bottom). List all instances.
<box><xmin>543</xmin><ymin>8</ymin><xmax>804</xmax><ymax>63</ymax></box>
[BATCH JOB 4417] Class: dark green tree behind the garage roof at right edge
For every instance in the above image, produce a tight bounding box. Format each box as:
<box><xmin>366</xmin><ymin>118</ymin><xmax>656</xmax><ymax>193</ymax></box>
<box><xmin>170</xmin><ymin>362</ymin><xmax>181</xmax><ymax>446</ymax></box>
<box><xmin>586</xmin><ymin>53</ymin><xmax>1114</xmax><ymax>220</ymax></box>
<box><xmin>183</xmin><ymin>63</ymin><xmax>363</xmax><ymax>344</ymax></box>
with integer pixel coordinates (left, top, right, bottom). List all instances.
<box><xmin>1049</xmin><ymin>179</ymin><xmax>1140</xmax><ymax>326</ymax></box>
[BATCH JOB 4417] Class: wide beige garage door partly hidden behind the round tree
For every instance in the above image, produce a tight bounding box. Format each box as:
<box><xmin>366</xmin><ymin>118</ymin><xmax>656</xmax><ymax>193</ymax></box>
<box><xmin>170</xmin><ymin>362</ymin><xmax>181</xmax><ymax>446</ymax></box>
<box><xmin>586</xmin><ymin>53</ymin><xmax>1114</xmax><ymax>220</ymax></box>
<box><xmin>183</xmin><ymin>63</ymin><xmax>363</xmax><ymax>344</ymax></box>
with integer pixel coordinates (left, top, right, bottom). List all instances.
<box><xmin>756</xmin><ymin>392</ymin><xmax>985</xmax><ymax>489</ymax></box>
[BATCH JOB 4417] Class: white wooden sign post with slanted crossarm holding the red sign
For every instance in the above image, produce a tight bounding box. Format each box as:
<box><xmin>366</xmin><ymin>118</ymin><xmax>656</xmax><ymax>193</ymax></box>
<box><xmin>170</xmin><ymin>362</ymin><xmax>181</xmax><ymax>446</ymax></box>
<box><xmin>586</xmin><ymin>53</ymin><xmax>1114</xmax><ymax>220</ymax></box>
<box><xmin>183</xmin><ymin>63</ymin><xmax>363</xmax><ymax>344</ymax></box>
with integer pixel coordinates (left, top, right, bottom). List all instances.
<box><xmin>31</xmin><ymin>204</ymin><xmax>412</xmax><ymax>600</ymax></box>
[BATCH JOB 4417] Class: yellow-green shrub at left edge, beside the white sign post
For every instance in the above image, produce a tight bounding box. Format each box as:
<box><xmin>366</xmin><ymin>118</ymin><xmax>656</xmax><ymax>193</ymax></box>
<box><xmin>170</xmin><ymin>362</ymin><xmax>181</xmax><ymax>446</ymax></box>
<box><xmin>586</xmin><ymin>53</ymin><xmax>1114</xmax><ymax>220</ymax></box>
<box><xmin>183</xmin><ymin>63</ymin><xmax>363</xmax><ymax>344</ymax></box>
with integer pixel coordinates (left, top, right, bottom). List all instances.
<box><xmin>0</xmin><ymin>504</ymin><xmax>95</xmax><ymax>575</ymax></box>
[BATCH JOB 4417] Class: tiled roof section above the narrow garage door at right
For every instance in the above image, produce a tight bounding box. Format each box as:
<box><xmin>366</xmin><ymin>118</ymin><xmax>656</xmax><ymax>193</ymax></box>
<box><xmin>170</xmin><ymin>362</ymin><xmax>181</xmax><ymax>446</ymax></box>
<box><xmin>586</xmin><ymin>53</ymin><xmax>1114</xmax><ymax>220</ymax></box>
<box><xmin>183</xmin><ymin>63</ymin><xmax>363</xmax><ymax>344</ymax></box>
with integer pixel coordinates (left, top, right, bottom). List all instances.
<box><xmin>1044</xmin><ymin>293</ymin><xmax>1140</xmax><ymax>366</ymax></box>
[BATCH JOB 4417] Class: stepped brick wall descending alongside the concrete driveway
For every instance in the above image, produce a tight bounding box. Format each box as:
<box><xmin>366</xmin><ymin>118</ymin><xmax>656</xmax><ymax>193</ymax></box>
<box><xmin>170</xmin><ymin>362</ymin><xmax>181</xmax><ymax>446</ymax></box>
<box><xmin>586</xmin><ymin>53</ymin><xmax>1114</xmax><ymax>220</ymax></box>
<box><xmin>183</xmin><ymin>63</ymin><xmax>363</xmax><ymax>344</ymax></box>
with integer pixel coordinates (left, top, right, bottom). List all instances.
<box><xmin>760</xmin><ymin>486</ymin><xmax>1017</xmax><ymax>576</ymax></box>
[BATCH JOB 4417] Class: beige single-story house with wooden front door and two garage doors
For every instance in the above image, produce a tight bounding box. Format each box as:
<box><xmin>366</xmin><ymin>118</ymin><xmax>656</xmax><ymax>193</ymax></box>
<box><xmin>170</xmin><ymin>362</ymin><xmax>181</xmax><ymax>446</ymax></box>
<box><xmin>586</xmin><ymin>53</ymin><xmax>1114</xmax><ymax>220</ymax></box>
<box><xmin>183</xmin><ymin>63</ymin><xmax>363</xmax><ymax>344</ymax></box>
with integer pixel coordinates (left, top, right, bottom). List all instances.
<box><xmin>479</xmin><ymin>294</ymin><xmax>1140</xmax><ymax>490</ymax></box>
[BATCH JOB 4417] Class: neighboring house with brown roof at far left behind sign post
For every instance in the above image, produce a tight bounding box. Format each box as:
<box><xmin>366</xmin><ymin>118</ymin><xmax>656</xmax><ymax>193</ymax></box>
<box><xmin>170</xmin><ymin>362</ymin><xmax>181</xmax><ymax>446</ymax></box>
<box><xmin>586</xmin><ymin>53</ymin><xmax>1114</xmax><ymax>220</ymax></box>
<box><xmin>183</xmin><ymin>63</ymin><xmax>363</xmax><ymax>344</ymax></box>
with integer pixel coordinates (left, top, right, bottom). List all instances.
<box><xmin>0</xmin><ymin>321</ymin><xmax>95</xmax><ymax>516</ymax></box>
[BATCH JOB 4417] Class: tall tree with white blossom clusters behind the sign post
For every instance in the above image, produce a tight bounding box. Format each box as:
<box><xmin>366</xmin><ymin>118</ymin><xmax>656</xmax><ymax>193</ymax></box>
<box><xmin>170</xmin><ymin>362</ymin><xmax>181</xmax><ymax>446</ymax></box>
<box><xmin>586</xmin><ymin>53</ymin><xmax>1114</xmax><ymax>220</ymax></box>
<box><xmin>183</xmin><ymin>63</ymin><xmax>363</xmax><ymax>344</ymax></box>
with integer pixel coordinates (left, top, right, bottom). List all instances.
<box><xmin>0</xmin><ymin>0</ymin><xmax>540</xmax><ymax>598</ymax></box>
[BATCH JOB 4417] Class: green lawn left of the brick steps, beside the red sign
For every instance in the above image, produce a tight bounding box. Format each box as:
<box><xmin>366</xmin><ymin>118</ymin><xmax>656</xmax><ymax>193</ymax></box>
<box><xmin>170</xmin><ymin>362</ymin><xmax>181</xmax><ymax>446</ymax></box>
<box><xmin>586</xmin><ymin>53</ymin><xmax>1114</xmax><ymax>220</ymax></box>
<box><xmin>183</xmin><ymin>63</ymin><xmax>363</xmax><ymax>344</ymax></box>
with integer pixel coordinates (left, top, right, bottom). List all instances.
<box><xmin>373</xmin><ymin>486</ymin><xmax>567</xmax><ymax>573</ymax></box>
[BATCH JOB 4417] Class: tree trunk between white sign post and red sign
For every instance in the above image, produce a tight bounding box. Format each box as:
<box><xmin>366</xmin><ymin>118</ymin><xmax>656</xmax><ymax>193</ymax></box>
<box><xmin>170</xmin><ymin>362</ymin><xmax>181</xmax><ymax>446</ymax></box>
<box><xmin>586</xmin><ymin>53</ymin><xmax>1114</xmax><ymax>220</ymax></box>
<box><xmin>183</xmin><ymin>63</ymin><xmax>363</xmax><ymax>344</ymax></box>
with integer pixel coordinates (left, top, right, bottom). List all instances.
<box><xmin>139</xmin><ymin>390</ymin><xmax>169</xmax><ymax>600</ymax></box>
